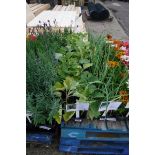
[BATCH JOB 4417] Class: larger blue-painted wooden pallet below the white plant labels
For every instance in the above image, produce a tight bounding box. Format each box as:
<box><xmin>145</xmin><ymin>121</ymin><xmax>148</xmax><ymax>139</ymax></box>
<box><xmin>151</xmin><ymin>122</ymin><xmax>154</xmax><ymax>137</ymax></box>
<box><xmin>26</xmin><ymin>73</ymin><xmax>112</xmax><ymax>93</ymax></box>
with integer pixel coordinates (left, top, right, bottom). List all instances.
<box><xmin>59</xmin><ymin>120</ymin><xmax>129</xmax><ymax>155</ymax></box>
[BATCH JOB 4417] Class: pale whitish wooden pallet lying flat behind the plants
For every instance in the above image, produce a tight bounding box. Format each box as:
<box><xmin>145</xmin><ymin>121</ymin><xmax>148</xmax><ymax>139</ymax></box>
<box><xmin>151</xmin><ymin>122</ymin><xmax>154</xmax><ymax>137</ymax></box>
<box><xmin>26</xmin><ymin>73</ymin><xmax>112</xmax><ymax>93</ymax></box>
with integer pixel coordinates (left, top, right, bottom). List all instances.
<box><xmin>27</xmin><ymin>5</ymin><xmax>86</xmax><ymax>33</ymax></box>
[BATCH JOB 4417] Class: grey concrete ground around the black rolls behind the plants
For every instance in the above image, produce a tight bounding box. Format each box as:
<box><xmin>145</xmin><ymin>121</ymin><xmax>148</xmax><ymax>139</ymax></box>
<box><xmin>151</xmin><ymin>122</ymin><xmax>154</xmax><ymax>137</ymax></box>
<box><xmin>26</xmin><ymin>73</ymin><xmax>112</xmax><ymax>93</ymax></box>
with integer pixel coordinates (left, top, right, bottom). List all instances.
<box><xmin>83</xmin><ymin>0</ymin><xmax>129</xmax><ymax>40</ymax></box>
